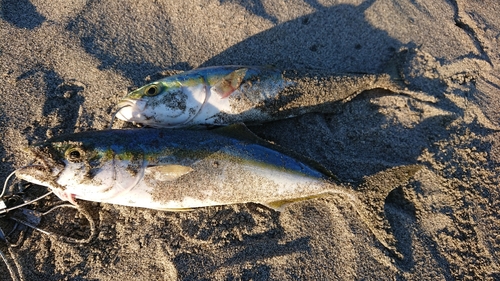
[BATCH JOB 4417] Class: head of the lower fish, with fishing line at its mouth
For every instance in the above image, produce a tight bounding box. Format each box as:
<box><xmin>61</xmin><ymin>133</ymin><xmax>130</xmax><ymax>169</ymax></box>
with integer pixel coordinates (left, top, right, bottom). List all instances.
<box><xmin>16</xmin><ymin>132</ymin><xmax>145</xmax><ymax>202</ymax></box>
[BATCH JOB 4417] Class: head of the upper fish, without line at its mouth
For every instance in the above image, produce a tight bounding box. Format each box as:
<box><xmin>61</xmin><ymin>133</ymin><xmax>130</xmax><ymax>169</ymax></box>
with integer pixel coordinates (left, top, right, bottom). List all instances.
<box><xmin>116</xmin><ymin>75</ymin><xmax>207</xmax><ymax>127</ymax></box>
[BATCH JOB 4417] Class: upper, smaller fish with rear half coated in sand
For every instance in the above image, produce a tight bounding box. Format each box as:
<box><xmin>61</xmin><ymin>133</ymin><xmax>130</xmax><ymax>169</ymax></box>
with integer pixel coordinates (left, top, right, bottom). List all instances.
<box><xmin>111</xmin><ymin>65</ymin><xmax>404</xmax><ymax>128</ymax></box>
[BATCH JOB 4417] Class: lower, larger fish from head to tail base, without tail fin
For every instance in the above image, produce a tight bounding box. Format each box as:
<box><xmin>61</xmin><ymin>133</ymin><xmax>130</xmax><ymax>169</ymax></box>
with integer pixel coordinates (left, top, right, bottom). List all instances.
<box><xmin>16</xmin><ymin>125</ymin><xmax>347</xmax><ymax>210</ymax></box>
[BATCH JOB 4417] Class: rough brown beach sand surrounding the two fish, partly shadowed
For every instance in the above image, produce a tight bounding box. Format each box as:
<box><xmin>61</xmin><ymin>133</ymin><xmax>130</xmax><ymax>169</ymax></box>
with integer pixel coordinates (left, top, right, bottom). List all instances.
<box><xmin>0</xmin><ymin>0</ymin><xmax>500</xmax><ymax>280</ymax></box>
